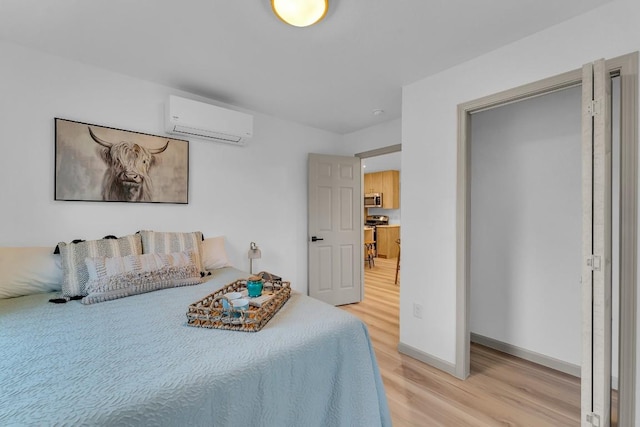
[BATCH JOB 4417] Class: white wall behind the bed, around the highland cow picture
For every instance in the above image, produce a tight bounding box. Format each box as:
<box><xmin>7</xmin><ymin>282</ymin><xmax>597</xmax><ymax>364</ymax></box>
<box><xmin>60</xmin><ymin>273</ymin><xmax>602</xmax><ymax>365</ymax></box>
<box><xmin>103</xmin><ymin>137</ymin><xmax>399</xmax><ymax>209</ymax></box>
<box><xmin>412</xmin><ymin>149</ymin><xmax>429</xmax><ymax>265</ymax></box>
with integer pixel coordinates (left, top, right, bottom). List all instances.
<box><xmin>0</xmin><ymin>42</ymin><xmax>342</xmax><ymax>292</ymax></box>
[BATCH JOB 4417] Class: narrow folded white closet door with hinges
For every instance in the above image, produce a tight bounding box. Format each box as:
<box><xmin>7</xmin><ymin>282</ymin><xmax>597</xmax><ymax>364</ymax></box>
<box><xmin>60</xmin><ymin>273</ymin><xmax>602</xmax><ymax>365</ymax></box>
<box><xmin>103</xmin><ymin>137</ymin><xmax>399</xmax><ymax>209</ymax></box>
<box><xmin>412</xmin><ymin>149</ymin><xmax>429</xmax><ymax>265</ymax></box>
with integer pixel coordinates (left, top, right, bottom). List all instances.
<box><xmin>581</xmin><ymin>60</ymin><xmax>611</xmax><ymax>427</ymax></box>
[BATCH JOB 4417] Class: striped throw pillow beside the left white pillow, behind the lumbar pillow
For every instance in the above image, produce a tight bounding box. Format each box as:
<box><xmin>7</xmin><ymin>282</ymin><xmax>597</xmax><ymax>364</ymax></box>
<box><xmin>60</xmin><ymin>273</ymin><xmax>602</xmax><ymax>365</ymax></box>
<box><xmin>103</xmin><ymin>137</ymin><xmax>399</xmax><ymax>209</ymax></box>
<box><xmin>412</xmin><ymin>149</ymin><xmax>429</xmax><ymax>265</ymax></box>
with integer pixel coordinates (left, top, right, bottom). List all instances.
<box><xmin>58</xmin><ymin>234</ymin><xmax>142</xmax><ymax>297</ymax></box>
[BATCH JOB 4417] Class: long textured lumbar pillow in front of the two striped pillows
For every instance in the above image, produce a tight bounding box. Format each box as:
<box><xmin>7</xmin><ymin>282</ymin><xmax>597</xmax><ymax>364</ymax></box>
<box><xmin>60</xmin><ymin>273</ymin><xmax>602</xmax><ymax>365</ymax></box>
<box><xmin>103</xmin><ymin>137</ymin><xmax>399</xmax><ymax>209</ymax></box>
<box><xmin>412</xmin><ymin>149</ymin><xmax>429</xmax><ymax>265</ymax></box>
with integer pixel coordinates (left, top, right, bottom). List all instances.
<box><xmin>82</xmin><ymin>250</ymin><xmax>202</xmax><ymax>304</ymax></box>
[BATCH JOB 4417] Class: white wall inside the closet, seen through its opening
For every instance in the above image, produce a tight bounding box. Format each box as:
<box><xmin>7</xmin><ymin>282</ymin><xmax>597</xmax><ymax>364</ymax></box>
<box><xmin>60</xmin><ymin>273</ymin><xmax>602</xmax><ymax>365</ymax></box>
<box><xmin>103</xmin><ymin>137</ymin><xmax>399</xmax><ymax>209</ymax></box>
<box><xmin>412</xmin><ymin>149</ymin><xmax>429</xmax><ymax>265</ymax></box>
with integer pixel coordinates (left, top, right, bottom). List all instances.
<box><xmin>470</xmin><ymin>87</ymin><xmax>582</xmax><ymax>366</ymax></box>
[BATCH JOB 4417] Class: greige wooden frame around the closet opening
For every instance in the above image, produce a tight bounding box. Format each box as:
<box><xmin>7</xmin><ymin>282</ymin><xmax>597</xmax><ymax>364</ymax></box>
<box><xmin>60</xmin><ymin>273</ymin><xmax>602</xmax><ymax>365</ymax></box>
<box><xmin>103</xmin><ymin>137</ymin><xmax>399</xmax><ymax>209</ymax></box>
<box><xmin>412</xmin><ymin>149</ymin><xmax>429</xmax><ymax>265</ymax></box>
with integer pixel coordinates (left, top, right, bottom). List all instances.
<box><xmin>455</xmin><ymin>52</ymin><xmax>638</xmax><ymax>425</ymax></box>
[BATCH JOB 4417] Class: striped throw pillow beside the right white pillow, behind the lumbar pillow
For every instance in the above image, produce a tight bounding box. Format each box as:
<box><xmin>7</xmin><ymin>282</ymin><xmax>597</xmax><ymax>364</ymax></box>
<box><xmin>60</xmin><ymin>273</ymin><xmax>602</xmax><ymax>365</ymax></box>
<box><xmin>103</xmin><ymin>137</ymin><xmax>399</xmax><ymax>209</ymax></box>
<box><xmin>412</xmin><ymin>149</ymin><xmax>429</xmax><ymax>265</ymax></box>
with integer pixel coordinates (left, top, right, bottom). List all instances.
<box><xmin>139</xmin><ymin>230</ymin><xmax>204</xmax><ymax>272</ymax></box>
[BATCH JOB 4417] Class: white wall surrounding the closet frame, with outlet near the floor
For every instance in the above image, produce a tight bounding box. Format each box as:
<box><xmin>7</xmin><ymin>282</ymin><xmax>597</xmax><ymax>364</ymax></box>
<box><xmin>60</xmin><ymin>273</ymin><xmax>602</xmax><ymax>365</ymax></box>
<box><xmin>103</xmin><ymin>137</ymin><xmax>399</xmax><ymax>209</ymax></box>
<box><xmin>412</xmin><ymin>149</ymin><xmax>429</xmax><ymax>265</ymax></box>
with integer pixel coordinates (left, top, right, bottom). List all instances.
<box><xmin>400</xmin><ymin>0</ymin><xmax>640</xmax><ymax>406</ymax></box>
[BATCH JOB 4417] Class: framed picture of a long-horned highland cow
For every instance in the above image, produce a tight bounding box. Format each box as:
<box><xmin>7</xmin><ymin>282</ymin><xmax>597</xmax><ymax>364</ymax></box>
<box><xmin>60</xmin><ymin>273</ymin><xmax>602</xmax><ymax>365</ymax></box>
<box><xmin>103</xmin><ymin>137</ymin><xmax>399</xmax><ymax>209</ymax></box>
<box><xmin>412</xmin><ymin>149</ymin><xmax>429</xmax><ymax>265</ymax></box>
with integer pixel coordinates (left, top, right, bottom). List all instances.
<box><xmin>55</xmin><ymin>118</ymin><xmax>189</xmax><ymax>203</ymax></box>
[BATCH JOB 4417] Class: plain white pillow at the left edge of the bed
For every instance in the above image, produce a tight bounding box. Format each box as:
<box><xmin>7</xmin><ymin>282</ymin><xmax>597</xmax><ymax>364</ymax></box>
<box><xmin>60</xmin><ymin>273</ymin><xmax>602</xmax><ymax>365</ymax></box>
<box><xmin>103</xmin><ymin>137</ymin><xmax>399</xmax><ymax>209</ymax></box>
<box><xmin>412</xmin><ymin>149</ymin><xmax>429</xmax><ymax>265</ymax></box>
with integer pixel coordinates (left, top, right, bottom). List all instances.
<box><xmin>0</xmin><ymin>247</ymin><xmax>62</xmax><ymax>299</ymax></box>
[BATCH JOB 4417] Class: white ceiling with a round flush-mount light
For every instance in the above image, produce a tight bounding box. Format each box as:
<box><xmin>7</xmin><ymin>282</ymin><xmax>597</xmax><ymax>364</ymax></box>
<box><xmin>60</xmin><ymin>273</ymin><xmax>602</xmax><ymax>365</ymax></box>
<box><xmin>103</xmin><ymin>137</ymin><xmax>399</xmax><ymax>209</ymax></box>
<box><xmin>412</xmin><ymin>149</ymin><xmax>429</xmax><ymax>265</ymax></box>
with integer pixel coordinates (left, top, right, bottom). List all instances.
<box><xmin>0</xmin><ymin>0</ymin><xmax>612</xmax><ymax>134</ymax></box>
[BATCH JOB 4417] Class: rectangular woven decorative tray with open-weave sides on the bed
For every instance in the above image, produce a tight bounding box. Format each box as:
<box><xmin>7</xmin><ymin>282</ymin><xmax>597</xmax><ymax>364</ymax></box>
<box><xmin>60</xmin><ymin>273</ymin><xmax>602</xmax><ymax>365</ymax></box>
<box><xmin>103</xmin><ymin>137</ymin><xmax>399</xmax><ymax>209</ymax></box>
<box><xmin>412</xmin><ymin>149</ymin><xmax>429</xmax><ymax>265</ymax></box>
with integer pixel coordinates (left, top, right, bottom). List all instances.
<box><xmin>187</xmin><ymin>279</ymin><xmax>291</xmax><ymax>332</ymax></box>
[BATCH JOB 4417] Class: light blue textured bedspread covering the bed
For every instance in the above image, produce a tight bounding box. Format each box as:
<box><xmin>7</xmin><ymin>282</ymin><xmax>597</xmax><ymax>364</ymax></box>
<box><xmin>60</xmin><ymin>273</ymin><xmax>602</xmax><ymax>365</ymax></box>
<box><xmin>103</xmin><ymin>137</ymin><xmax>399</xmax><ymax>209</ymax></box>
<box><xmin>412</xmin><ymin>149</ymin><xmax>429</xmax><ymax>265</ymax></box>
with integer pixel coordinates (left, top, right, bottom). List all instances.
<box><xmin>0</xmin><ymin>268</ymin><xmax>391</xmax><ymax>427</ymax></box>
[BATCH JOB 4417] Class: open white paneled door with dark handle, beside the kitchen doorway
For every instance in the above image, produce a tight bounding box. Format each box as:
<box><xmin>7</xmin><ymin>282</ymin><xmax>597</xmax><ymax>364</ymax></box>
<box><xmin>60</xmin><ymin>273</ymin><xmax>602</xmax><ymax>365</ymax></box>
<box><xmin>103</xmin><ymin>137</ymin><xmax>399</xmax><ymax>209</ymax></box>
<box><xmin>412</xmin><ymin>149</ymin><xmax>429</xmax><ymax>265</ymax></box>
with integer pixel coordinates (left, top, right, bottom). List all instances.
<box><xmin>308</xmin><ymin>154</ymin><xmax>364</xmax><ymax>305</ymax></box>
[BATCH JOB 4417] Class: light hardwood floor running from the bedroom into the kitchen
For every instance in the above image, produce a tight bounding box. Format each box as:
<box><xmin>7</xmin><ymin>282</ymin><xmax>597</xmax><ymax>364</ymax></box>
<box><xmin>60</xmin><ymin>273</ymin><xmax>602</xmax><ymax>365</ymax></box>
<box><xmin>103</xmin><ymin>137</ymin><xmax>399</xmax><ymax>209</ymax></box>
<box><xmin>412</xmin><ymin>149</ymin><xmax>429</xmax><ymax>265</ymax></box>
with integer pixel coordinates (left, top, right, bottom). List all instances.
<box><xmin>342</xmin><ymin>258</ymin><xmax>600</xmax><ymax>427</ymax></box>
